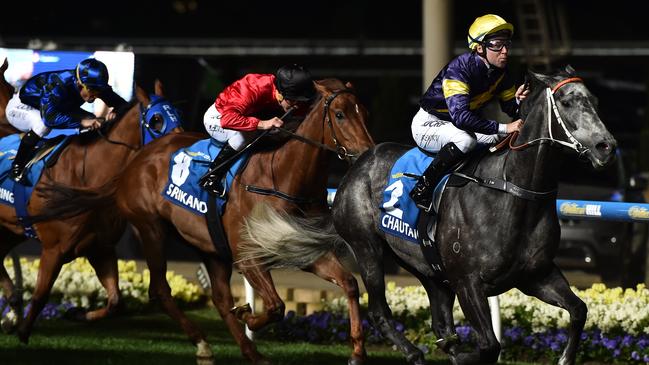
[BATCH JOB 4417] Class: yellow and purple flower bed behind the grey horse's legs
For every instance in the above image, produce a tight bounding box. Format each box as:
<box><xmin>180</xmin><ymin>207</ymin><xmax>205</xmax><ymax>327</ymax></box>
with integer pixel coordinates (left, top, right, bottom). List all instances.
<box><xmin>265</xmin><ymin>283</ymin><xmax>649</xmax><ymax>364</ymax></box>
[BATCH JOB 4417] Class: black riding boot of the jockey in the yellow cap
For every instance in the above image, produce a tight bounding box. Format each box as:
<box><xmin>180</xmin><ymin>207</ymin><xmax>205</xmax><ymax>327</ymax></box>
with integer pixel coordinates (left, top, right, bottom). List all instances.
<box><xmin>410</xmin><ymin>142</ymin><xmax>465</xmax><ymax>212</ymax></box>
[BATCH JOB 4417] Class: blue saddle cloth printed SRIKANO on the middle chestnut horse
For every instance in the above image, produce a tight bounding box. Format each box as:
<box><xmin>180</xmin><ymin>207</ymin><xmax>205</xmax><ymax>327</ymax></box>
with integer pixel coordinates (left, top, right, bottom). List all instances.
<box><xmin>161</xmin><ymin>138</ymin><xmax>249</xmax><ymax>215</ymax></box>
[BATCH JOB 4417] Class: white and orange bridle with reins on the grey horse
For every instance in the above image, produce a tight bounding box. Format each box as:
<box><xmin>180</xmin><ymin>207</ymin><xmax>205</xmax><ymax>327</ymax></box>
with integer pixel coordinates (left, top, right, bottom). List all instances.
<box><xmin>509</xmin><ymin>77</ymin><xmax>590</xmax><ymax>156</ymax></box>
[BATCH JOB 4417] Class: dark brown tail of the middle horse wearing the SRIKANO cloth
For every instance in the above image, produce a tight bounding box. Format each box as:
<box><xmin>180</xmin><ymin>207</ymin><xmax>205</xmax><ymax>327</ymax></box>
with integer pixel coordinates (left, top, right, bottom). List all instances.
<box><xmin>30</xmin><ymin>178</ymin><xmax>117</xmax><ymax>223</ymax></box>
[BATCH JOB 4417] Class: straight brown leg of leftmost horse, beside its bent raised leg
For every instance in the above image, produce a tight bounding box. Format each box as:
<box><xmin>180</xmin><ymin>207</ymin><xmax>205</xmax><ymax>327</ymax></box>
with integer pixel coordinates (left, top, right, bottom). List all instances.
<box><xmin>18</xmin><ymin>245</ymin><xmax>63</xmax><ymax>343</ymax></box>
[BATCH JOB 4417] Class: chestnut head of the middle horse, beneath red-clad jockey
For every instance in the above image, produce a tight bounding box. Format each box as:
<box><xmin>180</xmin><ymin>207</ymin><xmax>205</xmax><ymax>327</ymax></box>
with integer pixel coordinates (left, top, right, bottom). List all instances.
<box><xmin>314</xmin><ymin>79</ymin><xmax>374</xmax><ymax>163</ymax></box>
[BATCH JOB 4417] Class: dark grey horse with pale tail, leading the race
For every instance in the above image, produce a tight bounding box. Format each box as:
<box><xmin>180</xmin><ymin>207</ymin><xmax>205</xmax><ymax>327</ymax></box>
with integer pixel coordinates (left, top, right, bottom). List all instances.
<box><xmin>239</xmin><ymin>66</ymin><xmax>616</xmax><ymax>365</ymax></box>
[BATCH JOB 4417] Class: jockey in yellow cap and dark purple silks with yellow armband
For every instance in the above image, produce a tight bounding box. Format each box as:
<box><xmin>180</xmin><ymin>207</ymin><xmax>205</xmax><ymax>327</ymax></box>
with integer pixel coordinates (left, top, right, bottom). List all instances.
<box><xmin>410</xmin><ymin>14</ymin><xmax>528</xmax><ymax>211</ymax></box>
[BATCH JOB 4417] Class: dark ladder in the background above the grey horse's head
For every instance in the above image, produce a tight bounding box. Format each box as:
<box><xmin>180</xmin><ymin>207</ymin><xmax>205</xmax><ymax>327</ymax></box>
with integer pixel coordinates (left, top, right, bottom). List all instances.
<box><xmin>515</xmin><ymin>0</ymin><xmax>571</xmax><ymax>71</ymax></box>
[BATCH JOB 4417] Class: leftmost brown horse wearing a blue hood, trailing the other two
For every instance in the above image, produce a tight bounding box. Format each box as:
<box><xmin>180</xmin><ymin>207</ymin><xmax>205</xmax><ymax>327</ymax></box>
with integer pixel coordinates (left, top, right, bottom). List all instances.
<box><xmin>0</xmin><ymin>81</ymin><xmax>181</xmax><ymax>343</ymax></box>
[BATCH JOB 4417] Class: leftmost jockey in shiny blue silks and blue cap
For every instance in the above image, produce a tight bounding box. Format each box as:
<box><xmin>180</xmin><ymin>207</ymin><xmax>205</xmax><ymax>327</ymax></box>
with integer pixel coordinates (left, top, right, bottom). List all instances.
<box><xmin>6</xmin><ymin>58</ymin><xmax>126</xmax><ymax>183</ymax></box>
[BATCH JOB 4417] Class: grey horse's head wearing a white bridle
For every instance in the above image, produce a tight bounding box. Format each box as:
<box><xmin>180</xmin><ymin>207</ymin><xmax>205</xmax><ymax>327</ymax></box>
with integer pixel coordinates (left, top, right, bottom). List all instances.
<box><xmin>521</xmin><ymin>66</ymin><xmax>617</xmax><ymax>168</ymax></box>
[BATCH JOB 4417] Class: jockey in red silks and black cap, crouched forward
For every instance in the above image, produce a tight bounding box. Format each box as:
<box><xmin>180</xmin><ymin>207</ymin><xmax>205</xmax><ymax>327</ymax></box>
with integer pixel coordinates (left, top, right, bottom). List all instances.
<box><xmin>200</xmin><ymin>64</ymin><xmax>316</xmax><ymax>195</ymax></box>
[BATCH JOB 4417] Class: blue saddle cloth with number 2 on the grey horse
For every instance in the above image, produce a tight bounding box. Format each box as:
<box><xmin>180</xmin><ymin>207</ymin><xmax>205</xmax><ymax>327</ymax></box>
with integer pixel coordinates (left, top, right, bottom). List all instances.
<box><xmin>379</xmin><ymin>147</ymin><xmax>448</xmax><ymax>243</ymax></box>
